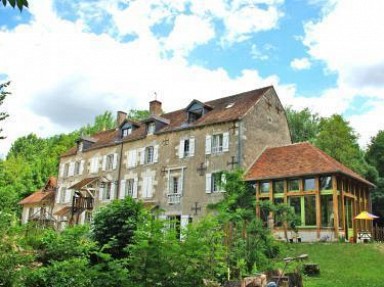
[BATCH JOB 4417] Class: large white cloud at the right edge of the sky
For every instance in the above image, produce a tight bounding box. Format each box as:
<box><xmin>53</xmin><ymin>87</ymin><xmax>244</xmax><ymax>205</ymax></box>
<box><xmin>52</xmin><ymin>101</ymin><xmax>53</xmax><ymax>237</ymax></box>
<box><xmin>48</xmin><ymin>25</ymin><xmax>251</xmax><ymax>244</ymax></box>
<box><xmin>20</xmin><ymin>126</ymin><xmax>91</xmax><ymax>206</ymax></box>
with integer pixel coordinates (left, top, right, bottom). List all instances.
<box><xmin>303</xmin><ymin>0</ymin><xmax>384</xmax><ymax>147</ymax></box>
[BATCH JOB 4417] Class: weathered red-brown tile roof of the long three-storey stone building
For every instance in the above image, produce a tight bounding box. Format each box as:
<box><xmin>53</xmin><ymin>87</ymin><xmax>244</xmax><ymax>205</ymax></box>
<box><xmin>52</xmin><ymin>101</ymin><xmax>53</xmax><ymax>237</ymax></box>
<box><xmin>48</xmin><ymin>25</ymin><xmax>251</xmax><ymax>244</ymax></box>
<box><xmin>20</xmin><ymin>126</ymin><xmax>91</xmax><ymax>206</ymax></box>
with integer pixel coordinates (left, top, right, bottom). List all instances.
<box><xmin>61</xmin><ymin>86</ymin><xmax>273</xmax><ymax>157</ymax></box>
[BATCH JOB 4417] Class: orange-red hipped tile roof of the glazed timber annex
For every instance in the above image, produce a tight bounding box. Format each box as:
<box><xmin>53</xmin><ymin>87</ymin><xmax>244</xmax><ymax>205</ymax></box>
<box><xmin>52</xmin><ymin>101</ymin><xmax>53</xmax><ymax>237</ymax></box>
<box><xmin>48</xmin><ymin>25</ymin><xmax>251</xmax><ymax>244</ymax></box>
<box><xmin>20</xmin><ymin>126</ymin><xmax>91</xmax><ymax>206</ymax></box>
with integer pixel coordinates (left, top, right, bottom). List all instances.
<box><xmin>245</xmin><ymin>143</ymin><xmax>374</xmax><ymax>186</ymax></box>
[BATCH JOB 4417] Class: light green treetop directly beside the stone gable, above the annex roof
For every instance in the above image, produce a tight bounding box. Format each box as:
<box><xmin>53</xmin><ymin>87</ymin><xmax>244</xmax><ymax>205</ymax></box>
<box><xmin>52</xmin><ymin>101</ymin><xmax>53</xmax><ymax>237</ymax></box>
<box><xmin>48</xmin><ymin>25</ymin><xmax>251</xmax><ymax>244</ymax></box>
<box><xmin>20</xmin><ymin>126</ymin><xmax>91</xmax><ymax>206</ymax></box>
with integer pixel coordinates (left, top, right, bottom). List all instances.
<box><xmin>285</xmin><ymin>107</ymin><xmax>320</xmax><ymax>143</ymax></box>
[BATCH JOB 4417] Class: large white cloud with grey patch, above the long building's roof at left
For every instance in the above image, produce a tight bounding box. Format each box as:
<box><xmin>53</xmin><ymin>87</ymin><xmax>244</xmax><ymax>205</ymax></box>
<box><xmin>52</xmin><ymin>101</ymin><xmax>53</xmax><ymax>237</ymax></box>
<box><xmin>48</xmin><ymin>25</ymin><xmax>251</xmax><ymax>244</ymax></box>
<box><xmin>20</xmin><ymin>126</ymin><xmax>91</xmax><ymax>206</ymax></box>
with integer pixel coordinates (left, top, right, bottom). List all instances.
<box><xmin>0</xmin><ymin>0</ymin><xmax>294</xmax><ymax>158</ymax></box>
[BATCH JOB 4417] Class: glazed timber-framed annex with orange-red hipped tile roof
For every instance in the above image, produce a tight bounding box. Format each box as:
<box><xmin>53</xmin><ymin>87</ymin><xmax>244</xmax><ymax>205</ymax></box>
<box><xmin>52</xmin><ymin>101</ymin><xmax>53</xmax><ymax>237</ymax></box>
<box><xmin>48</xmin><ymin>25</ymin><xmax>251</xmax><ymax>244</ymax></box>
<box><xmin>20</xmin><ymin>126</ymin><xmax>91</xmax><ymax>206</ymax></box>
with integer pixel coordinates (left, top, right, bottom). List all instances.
<box><xmin>246</xmin><ymin>143</ymin><xmax>374</xmax><ymax>241</ymax></box>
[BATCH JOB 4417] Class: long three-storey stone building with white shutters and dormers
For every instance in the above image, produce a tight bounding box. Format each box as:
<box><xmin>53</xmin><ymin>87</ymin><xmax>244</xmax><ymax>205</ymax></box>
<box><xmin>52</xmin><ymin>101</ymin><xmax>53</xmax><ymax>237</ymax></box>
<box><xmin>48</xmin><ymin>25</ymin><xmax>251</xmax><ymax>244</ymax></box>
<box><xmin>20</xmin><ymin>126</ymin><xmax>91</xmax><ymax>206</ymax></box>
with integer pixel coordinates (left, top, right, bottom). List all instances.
<box><xmin>54</xmin><ymin>87</ymin><xmax>291</xmax><ymax>231</ymax></box>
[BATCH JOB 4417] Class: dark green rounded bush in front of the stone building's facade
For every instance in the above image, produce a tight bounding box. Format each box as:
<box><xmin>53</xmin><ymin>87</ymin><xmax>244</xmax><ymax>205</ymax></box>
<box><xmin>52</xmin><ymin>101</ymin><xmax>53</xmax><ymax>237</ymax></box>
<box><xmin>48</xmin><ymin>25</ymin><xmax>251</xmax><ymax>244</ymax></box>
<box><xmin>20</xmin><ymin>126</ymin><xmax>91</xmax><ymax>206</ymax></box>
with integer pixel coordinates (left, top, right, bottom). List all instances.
<box><xmin>93</xmin><ymin>197</ymin><xmax>143</xmax><ymax>258</ymax></box>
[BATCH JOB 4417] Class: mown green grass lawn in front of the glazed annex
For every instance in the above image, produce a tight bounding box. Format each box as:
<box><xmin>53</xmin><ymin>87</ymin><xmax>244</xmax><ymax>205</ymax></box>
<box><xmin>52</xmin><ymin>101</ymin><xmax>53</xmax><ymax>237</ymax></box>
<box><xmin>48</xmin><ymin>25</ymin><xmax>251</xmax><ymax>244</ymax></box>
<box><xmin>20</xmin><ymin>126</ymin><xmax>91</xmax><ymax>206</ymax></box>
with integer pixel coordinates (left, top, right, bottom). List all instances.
<box><xmin>276</xmin><ymin>243</ymin><xmax>384</xmax><ymax>287</ymax></box>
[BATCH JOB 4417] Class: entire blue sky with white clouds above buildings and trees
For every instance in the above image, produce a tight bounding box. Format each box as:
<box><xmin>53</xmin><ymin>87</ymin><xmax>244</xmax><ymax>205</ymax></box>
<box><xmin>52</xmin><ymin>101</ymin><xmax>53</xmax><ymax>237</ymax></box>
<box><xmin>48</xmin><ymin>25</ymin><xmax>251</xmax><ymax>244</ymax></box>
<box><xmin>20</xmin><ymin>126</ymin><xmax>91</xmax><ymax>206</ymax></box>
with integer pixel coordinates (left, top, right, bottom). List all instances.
<box><xmin>0</xmin><ymin>0</ymin><xmax>384</xmax><ymax>156</ymax></box>
